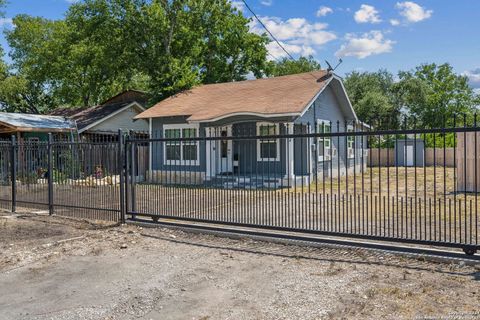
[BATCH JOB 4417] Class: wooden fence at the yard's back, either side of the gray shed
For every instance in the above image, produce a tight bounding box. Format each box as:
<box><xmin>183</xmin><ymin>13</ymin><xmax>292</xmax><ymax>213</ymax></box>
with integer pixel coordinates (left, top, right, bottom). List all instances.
<box><xmin>367</xmin><ymin>148</ymin><xmax>456</xmax><ymax>168</ymax></box>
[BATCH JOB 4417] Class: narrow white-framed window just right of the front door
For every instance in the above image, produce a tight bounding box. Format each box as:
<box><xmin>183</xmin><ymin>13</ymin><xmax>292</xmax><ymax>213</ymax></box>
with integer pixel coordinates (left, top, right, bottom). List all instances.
<box><xmin>257</xmin><ymin>123</ymin><xmax>280</xmax><ymax>161</ymax></box>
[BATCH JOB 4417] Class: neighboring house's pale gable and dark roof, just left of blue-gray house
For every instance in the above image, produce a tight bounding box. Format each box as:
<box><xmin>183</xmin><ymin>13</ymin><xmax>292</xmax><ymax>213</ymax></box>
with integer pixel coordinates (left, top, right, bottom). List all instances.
<box><xmin>51</xmin><ymin>90</ymin><xmax>148</xmax><ymax>141</ymax></box>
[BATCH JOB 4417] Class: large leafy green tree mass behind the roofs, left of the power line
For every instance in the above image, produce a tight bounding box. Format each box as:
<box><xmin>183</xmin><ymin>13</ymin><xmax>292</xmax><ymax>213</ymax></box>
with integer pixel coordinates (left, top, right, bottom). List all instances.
<box><xmin>7</xmin><ymin>0</ymin><xmax>268</xmax><ymax>109</ymax></box>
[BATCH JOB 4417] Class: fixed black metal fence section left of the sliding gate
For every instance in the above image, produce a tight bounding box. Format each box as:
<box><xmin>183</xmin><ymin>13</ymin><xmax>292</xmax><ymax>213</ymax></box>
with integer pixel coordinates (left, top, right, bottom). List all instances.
<box><xmin>0</xmin><ymin>136</ymin><xmax>124</xmax><ymax>221</ymax></box>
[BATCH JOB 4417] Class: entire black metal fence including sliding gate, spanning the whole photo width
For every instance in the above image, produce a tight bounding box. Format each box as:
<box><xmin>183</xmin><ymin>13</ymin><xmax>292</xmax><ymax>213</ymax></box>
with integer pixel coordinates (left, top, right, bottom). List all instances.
<box><xmin>0</xmin><ymin>122</ymin><xmax>480</xmax><ymax>254</ymax></box>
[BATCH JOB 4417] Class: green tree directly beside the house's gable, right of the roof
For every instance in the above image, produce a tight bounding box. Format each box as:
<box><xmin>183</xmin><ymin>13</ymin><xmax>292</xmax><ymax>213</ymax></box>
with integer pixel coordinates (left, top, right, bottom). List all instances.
<box><xmin>344</xmin><ymin>70</ymin><xmax>401</xmax><ymax>129</ymax></box>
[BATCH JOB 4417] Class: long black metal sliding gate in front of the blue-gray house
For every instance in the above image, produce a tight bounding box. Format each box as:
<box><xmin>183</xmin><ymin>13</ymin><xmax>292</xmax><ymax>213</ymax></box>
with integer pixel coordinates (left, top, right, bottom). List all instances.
<box><xmin>126</xmin><ymin>123</ymin><xmax>480</xmax><ymax>254</ymax></box>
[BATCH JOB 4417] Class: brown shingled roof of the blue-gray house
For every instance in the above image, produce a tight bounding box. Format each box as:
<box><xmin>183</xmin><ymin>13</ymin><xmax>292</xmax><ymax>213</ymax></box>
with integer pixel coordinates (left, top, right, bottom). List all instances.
<box><xmin>135</xmin><ymin>70</ymin><xmax>330</xmax><ymax>121</ymax></box>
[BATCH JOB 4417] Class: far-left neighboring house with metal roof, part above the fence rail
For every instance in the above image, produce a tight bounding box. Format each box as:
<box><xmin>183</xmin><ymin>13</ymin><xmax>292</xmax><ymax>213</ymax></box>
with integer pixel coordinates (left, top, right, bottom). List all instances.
<box><xmin>0</xmin><ymin>112</ymin><xmax>76</xmax><ymax>143</ymax></box>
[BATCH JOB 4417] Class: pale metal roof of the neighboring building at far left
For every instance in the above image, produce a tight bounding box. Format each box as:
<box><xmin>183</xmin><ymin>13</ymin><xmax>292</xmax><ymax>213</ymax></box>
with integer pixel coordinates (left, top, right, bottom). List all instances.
<box><xmin>0</xmin><ymin>112</ymin><xmax>76</xmax><ymax>132</ymax></box>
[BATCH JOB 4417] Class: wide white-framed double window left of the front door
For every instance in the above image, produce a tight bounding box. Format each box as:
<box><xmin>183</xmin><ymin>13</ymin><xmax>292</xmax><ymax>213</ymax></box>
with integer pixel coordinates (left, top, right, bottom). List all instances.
<box><xmin>164</xmin><ymin>125</ymin><xmax>199</xmax><ymax>165</ymax></box>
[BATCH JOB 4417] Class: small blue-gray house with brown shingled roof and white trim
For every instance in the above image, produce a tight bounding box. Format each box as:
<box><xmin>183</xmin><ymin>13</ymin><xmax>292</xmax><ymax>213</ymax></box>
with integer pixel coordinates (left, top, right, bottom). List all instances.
<box><xmin>136</xmin><ymin>71</ymin><xmax>367</xmax><ymax>185</ymax></box>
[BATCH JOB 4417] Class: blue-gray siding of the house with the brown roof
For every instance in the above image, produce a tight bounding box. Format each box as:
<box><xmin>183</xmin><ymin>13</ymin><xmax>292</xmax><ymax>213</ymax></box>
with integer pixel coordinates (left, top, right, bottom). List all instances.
<box><xmin>148</xmin><ymin>83</ymin><xmax>366</xmax><ymax>177</ymax></box>
